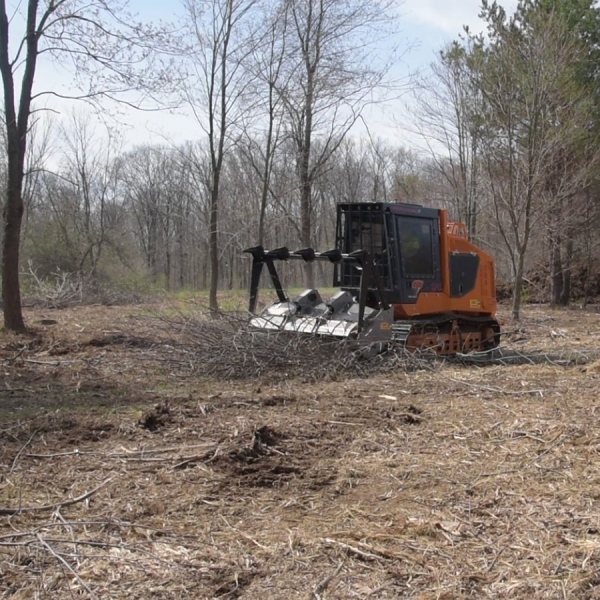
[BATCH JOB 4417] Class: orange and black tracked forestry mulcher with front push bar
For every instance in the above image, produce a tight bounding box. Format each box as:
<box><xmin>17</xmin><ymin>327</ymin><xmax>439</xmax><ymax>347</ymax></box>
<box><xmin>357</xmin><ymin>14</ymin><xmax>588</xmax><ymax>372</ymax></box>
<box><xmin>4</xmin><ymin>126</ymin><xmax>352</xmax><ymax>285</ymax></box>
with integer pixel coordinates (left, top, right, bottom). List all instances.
<box><xmin>244</xmin><ymin>202</ymin><xmax>500</xmax><ymax>355</ymax></box>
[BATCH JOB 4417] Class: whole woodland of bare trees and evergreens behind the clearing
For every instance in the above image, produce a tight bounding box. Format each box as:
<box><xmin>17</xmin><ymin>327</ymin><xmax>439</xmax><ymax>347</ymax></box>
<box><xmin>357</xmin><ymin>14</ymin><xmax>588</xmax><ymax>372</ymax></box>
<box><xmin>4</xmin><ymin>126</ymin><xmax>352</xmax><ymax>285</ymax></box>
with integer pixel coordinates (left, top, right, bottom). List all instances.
<box><xmin>0</xmin><ymin>0</ymin><xmax>600</xmax><ymax>331</ymax></box>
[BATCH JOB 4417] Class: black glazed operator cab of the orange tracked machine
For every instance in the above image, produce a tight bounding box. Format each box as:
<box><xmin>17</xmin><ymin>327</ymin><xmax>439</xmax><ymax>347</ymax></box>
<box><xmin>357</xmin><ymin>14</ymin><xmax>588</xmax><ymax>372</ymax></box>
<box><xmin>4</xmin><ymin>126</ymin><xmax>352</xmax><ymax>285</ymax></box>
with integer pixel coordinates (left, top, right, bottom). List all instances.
<box><xmin>334</xmin><ymin>202</ymin><xmax>442</xmax><ymax>305</ymax></box>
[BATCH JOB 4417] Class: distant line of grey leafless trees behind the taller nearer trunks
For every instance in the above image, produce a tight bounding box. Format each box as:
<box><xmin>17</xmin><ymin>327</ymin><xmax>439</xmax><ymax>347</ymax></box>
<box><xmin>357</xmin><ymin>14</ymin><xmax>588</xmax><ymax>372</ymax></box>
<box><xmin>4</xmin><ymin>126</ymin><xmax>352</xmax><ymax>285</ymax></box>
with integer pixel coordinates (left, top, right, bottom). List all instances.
<box><xmin>18</xmin><ymin>119</ymin><xmax>420</xmax><ymax>290</ymax></box>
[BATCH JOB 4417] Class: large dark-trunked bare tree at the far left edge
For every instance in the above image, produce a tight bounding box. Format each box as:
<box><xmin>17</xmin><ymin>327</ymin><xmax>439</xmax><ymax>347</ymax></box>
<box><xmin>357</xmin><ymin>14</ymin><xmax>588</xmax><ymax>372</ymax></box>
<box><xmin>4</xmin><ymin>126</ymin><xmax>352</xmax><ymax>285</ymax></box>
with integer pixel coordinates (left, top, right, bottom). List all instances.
<box><xmin>0</xmin><ymin>0</ymin><xmax>172</xmax><ymax>331</ymax></box>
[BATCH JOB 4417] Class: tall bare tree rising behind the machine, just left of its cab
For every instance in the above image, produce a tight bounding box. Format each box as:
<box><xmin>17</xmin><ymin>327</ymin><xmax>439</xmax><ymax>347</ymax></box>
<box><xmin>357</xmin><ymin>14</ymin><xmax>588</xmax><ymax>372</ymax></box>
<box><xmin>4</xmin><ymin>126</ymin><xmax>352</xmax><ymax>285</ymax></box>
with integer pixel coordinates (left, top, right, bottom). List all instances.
<box><xmin>282</xmin><ymin>0</ymin><xmax>394</xmax><ymax>287</ymax></box>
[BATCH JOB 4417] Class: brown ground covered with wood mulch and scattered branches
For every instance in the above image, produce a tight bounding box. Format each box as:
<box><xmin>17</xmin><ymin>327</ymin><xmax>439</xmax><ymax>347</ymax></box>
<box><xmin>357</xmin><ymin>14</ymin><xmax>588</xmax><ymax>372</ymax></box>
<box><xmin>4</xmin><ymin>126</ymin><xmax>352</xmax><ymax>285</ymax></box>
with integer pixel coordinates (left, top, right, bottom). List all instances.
<box><xmin>0</xmin><ymin>306</ymin><xmax>600</xmax><ymax>599</ymax></box>
